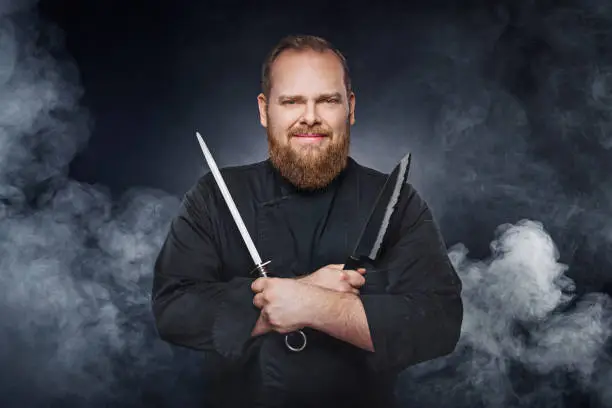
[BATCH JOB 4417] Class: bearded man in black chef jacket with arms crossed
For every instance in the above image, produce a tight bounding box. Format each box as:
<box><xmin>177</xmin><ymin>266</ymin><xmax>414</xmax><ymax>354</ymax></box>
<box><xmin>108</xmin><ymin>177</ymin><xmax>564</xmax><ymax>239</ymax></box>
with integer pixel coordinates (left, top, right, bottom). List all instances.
<box><xmin>152</xmin><ymin>36</ymin><xmax>463</xmax><ymax>408</ymax></box>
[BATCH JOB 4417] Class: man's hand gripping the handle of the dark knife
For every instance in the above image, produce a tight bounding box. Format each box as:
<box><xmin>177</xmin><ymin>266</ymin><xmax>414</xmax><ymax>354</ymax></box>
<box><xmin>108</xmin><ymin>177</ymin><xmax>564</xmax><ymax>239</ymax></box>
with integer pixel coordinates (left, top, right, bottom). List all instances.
<box><xmin>297</xmin><ymin>264</ymin><xmax>365</xmax><ymax>295</ymax></box>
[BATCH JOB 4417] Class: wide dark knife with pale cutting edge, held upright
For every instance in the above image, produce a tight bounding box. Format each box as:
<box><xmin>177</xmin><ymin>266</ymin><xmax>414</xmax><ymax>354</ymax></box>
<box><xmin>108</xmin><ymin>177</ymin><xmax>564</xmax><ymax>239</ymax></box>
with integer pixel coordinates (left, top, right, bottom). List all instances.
<box><xmin>344</xmin><ymin>153</ymin><xmax>412</xmax><ymax>270</ymax></box>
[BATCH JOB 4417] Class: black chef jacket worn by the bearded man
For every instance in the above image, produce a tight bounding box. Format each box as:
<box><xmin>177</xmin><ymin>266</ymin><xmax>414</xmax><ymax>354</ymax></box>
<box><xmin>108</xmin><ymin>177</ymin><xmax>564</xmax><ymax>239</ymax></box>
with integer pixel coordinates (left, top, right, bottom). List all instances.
<box><xmin>153</xmin><ymin>157</ymin><xmax>463</xmax><ymax>408</ymax></box>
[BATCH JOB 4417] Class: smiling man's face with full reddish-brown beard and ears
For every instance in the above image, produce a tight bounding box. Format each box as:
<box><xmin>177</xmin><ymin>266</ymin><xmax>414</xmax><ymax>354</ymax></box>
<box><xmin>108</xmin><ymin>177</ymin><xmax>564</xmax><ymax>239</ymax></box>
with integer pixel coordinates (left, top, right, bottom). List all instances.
<box><xmin>257</xmin><ymin>50</ymin><xmax>355</xmax><ymax>189</ymax></box>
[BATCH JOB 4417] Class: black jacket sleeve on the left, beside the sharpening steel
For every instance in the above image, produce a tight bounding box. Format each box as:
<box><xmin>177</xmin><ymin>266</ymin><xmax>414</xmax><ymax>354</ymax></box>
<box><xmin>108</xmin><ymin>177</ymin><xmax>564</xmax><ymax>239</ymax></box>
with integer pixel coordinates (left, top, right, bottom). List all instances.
<box><xmin>152</xmin><ymin>176</ymin><xmax>259</xmax><ymax>360</ymax></box>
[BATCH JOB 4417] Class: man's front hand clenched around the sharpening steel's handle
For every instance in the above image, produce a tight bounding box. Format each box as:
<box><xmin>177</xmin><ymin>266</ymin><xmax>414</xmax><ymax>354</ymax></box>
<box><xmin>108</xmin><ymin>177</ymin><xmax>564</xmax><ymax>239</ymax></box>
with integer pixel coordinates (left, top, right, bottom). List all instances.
<box><xmin>251</xmin><ymin>278</ymin><xmax>322</xmax><ymax>334</ymax></box>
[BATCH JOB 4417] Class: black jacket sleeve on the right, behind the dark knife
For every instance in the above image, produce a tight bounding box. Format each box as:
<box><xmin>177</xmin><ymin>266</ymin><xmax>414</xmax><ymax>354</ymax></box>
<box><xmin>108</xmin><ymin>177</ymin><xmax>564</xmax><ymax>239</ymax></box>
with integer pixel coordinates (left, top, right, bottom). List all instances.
<box><xmin>360</xmin><ymin>184</ymin><xmax>463</xmax><ymax>372</ymax></box>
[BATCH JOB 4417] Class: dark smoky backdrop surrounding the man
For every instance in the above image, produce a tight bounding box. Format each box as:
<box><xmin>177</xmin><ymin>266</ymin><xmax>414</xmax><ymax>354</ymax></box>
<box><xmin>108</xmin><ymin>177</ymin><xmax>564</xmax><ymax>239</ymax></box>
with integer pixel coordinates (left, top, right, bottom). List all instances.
<box><xmin>0</xmin><ymin>0</ymin><xmax>612</xmax><ymax>407</ymax></box>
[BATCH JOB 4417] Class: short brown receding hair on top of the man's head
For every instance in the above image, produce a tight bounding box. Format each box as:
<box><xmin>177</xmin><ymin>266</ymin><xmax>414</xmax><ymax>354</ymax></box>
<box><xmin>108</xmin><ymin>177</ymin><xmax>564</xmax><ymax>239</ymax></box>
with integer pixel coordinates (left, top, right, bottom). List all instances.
<box><xmin>261</xmin><ymin>35</ymin><xmax>351</xmax><ymax>99</ymax></box>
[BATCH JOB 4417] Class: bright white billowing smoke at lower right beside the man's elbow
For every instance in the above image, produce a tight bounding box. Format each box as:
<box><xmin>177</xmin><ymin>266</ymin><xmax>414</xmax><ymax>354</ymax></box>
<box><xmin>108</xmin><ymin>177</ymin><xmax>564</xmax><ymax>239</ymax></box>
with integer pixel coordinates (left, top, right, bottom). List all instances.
<box><xmin>401</xmin><ymin>220</ymin><xmax>612</xmax><ymax>407</ymax></box>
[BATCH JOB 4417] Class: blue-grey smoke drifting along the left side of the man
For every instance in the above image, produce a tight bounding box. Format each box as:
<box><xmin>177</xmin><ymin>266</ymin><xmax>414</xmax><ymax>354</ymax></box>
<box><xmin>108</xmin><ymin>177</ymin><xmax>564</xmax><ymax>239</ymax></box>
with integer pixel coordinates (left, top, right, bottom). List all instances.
<box><xmin>0</xmin><ymin>2</ymin><xmax>197</xmax><ymax>406</ymax></box>
